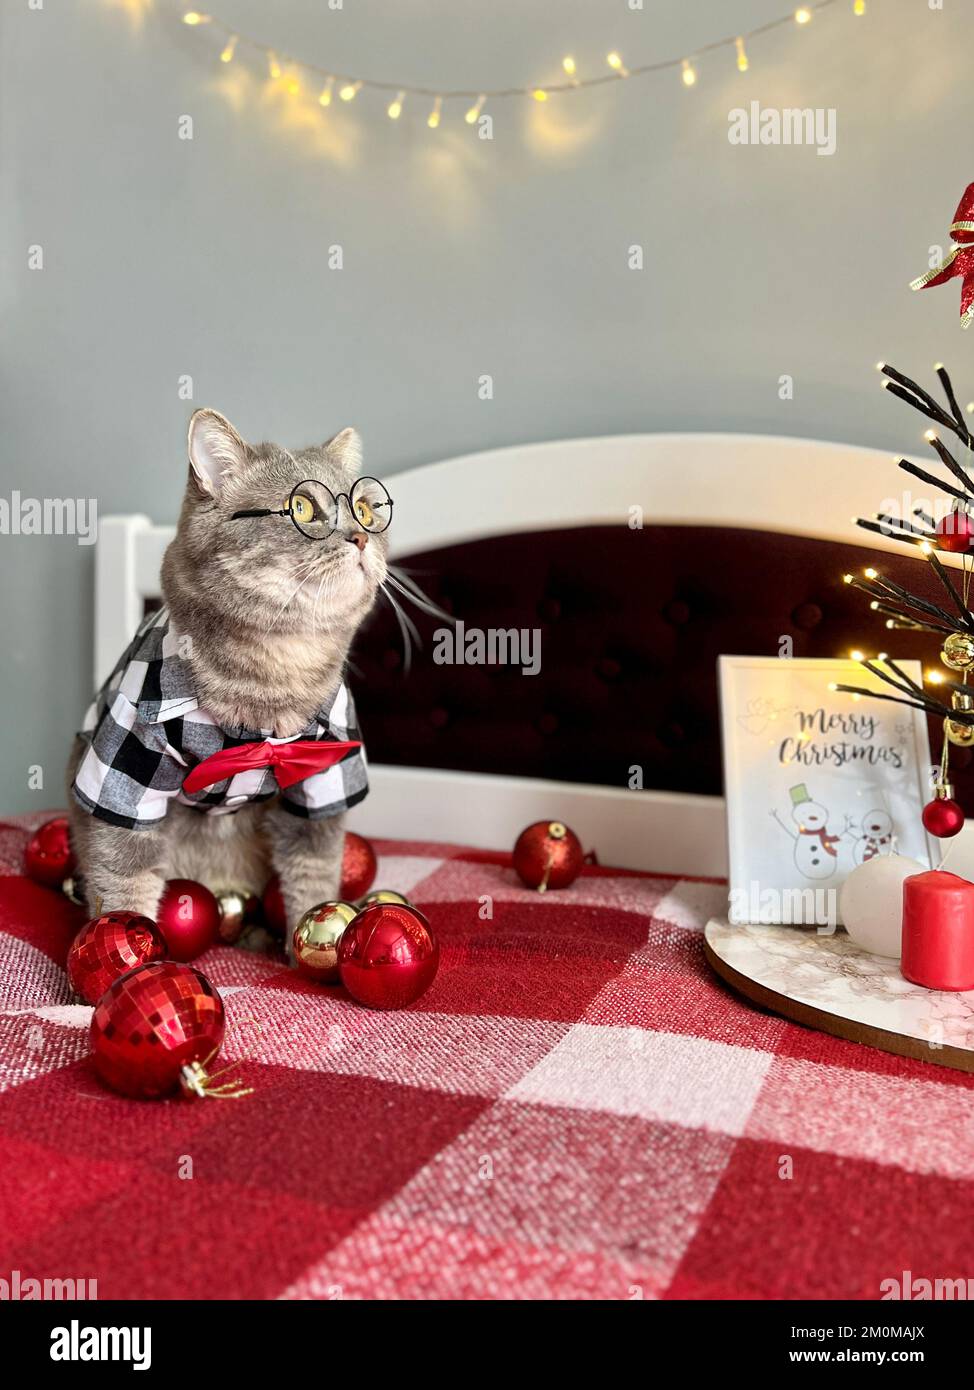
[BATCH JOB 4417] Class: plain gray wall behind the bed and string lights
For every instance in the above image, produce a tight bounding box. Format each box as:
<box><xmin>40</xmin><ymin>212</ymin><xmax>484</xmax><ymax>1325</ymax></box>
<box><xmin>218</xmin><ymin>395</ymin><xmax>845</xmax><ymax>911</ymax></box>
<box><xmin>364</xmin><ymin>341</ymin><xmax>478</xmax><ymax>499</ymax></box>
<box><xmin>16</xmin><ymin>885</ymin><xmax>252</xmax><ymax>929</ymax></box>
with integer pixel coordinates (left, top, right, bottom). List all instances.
<box><xmin>0</xmin><ymin>0</ymin><xmax>974</xmax><ymax>812</ymax></box>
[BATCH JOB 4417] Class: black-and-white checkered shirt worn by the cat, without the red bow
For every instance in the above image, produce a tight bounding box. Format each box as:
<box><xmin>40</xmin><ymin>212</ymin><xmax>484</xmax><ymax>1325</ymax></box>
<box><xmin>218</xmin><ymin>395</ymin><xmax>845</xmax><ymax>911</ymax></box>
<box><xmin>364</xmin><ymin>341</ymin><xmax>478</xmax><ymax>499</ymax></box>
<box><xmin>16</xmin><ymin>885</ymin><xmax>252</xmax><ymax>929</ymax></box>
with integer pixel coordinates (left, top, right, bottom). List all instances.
<box><xmin>71</xmin><ymin>607</ymin><xmax>368</xmax><ymax>830</ymax></box>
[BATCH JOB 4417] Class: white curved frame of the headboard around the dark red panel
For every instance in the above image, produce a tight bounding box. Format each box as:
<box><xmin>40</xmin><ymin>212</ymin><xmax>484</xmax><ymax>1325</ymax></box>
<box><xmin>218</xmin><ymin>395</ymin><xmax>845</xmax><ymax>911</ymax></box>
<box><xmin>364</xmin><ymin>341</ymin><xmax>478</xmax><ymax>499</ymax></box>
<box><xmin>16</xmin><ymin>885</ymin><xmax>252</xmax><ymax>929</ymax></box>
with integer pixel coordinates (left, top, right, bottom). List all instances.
<box><xmin>94</xmin><ymin>434</ymin><xmax>930</xmax><ymax>876</ymax></box>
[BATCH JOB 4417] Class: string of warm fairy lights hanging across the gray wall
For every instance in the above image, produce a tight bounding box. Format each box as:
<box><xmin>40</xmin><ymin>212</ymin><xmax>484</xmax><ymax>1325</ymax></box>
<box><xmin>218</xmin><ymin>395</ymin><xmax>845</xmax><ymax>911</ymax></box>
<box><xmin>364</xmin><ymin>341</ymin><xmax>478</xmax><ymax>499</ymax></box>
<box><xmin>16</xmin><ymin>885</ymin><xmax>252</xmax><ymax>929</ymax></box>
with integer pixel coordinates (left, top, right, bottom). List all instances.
<box><xmin>172</xmin><ymin>0</ymin><xmax>866</xmax><ymax>131</ymax></box>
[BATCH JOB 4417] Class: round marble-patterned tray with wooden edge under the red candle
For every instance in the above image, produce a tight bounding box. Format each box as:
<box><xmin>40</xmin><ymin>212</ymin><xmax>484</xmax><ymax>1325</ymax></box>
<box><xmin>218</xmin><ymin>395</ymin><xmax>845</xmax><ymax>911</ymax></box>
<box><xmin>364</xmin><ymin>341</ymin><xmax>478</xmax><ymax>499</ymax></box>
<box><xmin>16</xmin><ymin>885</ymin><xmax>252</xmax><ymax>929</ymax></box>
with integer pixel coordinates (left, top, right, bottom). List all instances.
<box><xmin>703</xmin><ymin>917</ymin><xmax>974</xmax><ymax>1072</ymax></box>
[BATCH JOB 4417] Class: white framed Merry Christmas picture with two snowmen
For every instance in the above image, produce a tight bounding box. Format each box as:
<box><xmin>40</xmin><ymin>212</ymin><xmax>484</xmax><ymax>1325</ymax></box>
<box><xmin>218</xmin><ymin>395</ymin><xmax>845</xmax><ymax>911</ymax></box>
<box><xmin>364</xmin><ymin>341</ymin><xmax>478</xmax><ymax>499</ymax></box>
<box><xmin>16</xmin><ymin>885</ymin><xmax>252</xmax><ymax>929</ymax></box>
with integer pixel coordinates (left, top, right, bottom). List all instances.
<box><xmin>717</xmin><ymin>656</ymin><xmax>934</xmax><ymax>927</ymax></box>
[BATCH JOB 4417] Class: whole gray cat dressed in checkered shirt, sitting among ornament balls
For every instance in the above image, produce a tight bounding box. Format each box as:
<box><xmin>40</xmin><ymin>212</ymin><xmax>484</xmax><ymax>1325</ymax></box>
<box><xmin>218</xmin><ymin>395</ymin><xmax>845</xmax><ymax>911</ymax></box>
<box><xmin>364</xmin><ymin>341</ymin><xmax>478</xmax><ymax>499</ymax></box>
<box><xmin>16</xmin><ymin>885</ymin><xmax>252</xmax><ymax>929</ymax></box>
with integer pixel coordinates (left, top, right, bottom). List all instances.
<box><xmin>68</xmin><ymin>410</ymin><xmax>390</xmax><ymax>935</ymax></box>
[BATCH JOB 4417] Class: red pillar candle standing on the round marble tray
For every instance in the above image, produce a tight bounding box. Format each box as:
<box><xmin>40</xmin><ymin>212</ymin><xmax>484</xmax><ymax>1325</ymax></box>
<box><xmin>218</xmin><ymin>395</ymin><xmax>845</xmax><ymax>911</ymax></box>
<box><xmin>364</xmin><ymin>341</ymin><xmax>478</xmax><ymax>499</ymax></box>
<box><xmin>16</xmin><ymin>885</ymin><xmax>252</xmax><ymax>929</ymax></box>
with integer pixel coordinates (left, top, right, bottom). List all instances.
<box><xmin>900</xmin><ymin>869</ymin><xmax>974</xmax><ymax>990</ymax></box>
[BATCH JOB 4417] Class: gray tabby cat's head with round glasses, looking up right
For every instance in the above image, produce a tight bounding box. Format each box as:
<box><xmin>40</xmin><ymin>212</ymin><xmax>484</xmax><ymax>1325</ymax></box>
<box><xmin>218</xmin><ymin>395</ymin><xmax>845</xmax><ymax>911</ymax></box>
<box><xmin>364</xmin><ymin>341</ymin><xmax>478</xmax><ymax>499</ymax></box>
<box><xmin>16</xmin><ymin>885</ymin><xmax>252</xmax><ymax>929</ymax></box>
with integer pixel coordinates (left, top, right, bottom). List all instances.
<box><xmin>178</xmin><ymin>410</ymin><xmax>389</xmax><ymax>639</ymax></box>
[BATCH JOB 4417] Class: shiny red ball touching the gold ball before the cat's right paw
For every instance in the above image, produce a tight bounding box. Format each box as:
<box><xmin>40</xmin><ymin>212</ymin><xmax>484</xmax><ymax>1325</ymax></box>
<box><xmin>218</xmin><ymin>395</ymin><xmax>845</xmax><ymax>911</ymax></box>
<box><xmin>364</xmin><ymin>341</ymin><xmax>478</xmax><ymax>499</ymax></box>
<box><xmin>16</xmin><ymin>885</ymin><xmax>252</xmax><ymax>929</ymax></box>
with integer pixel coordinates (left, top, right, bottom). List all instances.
<box><xmin>338</xmin><ymin>902</ymin><xmax>439</xmax><ymax>1009</ymax></box>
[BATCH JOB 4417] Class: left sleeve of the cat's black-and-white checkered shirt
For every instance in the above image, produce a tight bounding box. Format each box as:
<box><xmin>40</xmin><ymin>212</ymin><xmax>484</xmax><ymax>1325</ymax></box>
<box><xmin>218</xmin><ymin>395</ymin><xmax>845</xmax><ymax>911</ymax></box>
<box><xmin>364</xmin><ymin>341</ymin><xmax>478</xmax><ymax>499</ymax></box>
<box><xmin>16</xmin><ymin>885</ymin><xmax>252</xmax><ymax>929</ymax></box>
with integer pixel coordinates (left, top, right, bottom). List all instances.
<box><xmin>71</xmin><ymin>694</ymin><xmax>186</xmax><ymax>830</ymax></box>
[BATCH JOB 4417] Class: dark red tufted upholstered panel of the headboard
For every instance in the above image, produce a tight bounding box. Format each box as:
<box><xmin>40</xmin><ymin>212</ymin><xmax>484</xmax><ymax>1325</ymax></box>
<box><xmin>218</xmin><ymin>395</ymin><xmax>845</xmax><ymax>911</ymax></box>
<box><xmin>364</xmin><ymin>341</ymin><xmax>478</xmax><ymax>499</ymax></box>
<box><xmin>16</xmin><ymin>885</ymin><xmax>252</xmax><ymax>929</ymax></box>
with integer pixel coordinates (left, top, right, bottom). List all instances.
<box><xmin>352</xmin><ymin>525</ymin><xmax>974</xmax><ymax>810</ymax></box>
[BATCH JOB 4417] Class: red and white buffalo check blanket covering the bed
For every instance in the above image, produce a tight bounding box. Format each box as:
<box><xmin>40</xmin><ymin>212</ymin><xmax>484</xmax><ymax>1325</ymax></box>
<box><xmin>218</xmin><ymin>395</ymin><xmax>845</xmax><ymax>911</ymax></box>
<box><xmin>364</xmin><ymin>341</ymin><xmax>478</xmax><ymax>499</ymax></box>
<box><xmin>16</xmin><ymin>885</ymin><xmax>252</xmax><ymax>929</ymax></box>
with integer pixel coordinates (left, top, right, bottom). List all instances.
<box><xmin>0</xmin><ymin>816</ymin><xmax>974</xmax><ymax>1300</ymax></box>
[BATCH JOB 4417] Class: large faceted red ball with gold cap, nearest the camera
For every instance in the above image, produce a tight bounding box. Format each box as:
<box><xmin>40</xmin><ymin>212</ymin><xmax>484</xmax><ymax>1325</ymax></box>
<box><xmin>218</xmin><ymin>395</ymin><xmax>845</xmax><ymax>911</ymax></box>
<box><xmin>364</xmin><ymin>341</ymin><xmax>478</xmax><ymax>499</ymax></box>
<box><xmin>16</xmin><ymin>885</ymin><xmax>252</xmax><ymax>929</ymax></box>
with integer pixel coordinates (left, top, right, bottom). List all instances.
<box><xmin>90</xmin><ymin>960</ymin><xmax>224</xmax><ymax>1099</ymax></box>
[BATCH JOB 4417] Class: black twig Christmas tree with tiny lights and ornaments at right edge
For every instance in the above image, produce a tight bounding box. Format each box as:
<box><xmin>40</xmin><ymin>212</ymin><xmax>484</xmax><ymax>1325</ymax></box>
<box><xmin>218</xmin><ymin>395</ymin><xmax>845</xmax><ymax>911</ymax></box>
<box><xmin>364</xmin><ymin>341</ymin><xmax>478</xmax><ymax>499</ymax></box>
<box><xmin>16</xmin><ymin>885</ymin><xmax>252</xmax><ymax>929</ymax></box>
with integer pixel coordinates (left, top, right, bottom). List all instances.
<box><xmin>834</xmin><ymin>361</ymin><xmax>974</xmax><ymax>837</ymax></box>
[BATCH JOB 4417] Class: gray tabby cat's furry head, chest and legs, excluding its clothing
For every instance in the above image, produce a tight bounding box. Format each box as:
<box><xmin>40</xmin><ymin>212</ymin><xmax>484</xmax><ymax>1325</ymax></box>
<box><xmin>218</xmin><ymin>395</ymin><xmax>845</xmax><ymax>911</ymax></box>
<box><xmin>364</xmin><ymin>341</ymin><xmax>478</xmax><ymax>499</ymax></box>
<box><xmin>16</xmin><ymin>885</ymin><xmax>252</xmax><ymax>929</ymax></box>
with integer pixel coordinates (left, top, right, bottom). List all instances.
<box><xmin>68</xmin><ymin>410</ymin><xmax>388</xmax><ymax>929</ymax></box>
